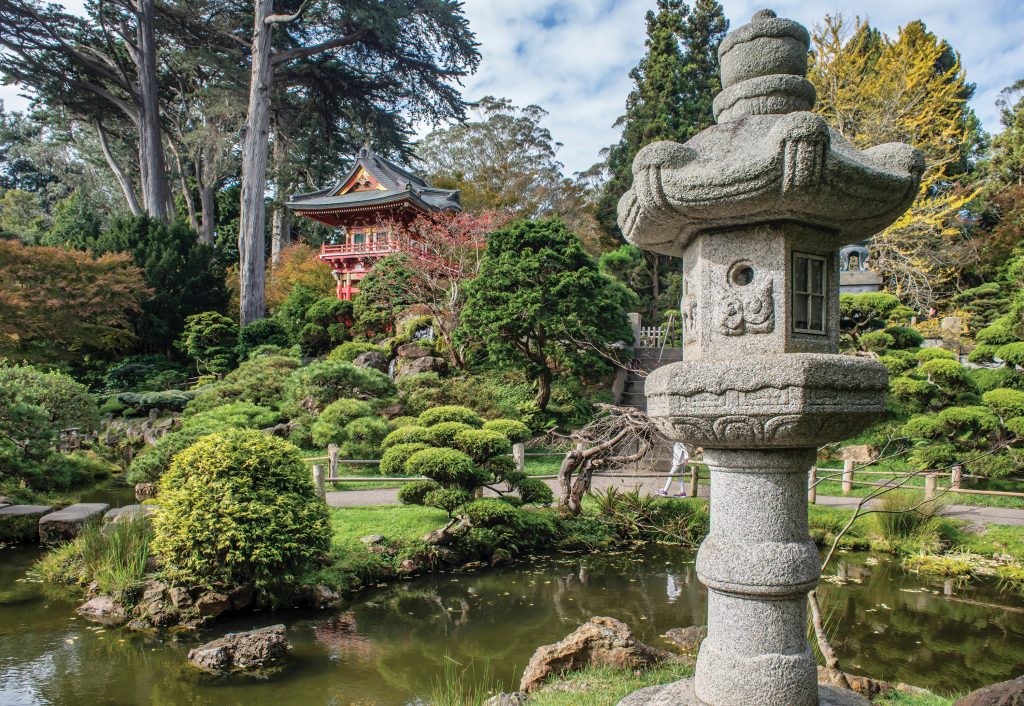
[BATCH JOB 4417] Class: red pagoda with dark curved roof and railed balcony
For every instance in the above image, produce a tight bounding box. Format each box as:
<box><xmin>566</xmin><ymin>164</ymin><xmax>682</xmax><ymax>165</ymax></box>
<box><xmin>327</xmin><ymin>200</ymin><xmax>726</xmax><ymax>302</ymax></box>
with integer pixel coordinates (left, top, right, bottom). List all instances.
<box><xmin>288</xmin><ymin>146</ymin><xmax>462</xmax><ymax>300</ymax></box>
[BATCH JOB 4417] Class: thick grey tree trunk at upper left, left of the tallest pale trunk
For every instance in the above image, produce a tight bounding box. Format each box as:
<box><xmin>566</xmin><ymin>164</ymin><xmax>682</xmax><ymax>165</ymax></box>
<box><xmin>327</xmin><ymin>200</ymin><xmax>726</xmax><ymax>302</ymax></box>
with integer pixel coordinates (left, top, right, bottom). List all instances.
<box><xmin>135</xmin><ymin>0</ymin><xmax>173</xmax><ymax>222</ymax></box>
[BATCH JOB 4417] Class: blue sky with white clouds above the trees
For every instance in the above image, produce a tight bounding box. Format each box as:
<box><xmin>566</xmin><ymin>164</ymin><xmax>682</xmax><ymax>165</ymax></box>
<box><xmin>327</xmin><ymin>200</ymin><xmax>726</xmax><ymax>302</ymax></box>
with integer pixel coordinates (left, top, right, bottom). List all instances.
<box><xmin>0</xmin><ymin>0</ymin><xmax>1024</xmax><ymax>171</ymax></box>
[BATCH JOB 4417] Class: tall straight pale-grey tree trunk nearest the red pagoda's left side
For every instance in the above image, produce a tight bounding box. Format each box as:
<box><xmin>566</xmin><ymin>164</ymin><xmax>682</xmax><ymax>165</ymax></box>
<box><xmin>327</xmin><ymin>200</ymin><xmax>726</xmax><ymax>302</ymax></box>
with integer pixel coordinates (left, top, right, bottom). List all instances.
<box><xmin>239</xmin><ymin>0</ymin><xmax>273</xmax><ymax>326</ymax></box>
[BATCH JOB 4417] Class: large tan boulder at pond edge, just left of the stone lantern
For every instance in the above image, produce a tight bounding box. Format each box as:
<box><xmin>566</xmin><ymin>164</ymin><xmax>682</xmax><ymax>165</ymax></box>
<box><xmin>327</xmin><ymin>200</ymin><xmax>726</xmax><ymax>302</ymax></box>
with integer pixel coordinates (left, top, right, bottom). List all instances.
<box><xmin>519</xmin><ymin>617</ymin><xmax>674</xmax><ymax>692</ymax></box>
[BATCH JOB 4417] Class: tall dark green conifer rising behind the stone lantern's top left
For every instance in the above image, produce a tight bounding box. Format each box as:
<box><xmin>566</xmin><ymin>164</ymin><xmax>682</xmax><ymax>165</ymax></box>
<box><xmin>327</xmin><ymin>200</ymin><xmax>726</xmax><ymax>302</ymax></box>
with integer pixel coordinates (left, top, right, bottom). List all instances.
<box><xmin>597</xmin><ymin>0</ymin><xmax>729</xmax><ymax>236</ymax></box>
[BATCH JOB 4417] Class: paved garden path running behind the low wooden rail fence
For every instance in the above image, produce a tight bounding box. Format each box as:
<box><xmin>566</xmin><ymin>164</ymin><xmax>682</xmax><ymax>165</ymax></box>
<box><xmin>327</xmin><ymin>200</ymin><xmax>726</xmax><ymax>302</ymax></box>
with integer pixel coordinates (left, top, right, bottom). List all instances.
<box><xmin>327</xmin><ymin>475</ymin><xmax>1024</xmax><ymax>526</ymax></box>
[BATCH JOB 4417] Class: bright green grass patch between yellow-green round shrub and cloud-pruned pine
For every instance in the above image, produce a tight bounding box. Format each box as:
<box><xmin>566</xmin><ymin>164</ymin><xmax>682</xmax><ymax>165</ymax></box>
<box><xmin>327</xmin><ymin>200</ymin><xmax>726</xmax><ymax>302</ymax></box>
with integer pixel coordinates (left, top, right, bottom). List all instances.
<box><xmin>323</xmin><ymin>505</ymin><xmax>447</xmax><ymax>546</ymax></box>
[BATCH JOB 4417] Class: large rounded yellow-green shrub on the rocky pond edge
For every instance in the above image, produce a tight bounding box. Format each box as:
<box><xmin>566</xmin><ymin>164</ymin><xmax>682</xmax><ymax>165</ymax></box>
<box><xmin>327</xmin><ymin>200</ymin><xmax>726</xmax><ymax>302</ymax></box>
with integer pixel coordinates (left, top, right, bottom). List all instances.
<box><xmin>153</xmin><ymin>429</ymin><xmax>331</xmax><ymax>600</ymax></box>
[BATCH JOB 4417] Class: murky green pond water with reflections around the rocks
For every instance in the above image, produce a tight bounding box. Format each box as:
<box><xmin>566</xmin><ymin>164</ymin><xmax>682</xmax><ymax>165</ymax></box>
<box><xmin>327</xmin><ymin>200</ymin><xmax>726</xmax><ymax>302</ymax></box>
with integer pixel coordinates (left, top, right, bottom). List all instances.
<box><xmin>0</xmin><ymin>545</ymin><xmax>1024</xmax><ymax>706</ymax></box>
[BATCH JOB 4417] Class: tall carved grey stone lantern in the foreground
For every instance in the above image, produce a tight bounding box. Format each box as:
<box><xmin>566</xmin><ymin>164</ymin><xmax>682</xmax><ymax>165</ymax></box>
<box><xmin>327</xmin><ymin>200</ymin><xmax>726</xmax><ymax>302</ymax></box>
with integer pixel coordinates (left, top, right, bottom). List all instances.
<box><xmin>618</xmin><ymin>10</ymin><xmax>924</xmax><ymax>706</ymax></box>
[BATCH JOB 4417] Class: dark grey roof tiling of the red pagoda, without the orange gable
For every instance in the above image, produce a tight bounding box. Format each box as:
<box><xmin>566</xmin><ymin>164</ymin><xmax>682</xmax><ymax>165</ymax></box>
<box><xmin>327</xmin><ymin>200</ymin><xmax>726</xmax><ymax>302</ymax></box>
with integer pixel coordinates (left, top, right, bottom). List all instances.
<box><xmin>288</xmin><ymin>141</ymin><xmax>462</xmax><ymax>211</ymax></box>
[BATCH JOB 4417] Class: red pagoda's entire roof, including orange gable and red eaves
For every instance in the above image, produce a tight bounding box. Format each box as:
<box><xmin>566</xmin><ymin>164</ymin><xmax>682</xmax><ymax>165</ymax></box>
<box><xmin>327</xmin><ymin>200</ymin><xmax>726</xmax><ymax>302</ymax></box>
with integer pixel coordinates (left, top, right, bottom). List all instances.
<box><xmin>288</xmin><ymin>146</ymin><xmax>462</xmax><ymax>227</ymax></box>
